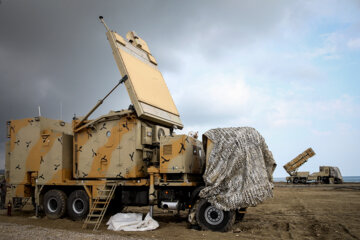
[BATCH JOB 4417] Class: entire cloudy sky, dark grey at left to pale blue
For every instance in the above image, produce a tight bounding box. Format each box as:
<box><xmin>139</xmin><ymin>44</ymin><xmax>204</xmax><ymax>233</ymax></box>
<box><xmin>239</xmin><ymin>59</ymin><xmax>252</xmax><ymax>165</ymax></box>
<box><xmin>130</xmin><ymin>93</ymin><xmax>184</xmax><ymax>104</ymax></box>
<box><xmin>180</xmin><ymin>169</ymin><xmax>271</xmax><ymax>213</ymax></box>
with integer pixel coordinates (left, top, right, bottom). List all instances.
<box><xmin>0</xmin><ymin>0</ymin><xmax>360</xmax><ymax>176</ymax></box>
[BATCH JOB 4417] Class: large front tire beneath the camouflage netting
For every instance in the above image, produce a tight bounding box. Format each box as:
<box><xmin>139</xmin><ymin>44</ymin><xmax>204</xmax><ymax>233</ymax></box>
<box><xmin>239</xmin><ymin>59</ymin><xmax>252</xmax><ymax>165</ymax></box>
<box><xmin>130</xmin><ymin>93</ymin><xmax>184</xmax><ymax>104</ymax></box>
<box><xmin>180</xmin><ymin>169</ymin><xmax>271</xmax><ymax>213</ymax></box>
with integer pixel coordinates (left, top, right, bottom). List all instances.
<box><xmin>196</xmin><ymin>199</ymin><xmax>235</xmax><ymax>232</ymax></box>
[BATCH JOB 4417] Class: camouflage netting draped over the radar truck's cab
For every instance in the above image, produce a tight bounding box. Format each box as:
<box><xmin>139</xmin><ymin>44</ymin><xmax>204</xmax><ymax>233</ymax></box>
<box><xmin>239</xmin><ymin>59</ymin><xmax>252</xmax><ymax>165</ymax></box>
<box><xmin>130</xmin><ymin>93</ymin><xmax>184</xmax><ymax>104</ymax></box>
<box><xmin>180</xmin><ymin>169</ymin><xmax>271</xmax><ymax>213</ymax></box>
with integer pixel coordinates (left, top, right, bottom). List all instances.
<box><xmin>200</xmin><ymin>127</ymin><xmax>276</xmax><ymax>211</ymax></box>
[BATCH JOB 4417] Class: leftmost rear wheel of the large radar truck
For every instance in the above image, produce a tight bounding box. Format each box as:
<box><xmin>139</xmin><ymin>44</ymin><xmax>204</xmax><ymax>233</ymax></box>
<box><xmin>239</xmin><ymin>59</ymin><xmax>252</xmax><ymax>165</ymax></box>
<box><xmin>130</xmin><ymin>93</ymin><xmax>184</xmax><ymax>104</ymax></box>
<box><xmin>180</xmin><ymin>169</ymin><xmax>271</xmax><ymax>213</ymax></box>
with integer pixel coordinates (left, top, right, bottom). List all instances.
<box><xmin>43</xmin><ymin>189</ymin><xmax>66</xmax><ymax>219</ymax></box>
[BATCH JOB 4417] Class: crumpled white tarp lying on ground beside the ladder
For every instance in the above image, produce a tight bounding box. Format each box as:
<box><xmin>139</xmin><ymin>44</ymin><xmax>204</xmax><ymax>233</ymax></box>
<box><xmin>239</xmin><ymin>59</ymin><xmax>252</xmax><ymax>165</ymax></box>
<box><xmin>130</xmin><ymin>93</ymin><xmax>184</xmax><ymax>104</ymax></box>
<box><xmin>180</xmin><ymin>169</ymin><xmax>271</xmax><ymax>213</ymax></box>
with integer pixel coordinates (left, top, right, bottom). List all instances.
<box><xmin>106</xmin><ymin>213</ymin><xmax>159</xmax><ymax>231</ymax></box>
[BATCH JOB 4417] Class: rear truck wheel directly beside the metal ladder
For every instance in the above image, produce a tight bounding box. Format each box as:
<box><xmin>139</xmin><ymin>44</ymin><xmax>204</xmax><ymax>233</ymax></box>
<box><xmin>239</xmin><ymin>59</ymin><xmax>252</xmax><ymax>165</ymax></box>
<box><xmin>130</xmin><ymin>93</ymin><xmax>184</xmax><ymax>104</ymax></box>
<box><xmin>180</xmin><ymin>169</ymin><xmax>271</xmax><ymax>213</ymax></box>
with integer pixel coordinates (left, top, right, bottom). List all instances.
<box><xmin>67</xmin><ymin>190</ymin><xmax>89</xmax><ymax>221</ymax></box>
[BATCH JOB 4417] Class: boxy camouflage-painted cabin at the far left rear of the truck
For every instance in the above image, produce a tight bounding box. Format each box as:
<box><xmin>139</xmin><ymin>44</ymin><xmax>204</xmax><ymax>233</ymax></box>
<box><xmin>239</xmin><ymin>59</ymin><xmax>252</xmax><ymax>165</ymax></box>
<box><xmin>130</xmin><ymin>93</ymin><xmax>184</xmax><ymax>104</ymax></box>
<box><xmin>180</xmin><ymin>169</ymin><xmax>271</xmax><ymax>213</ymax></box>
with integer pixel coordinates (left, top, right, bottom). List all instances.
<box><xmin>6</xmin><ymin>117</ymin><xmax>72</xmax><ymax>197</ymax></box>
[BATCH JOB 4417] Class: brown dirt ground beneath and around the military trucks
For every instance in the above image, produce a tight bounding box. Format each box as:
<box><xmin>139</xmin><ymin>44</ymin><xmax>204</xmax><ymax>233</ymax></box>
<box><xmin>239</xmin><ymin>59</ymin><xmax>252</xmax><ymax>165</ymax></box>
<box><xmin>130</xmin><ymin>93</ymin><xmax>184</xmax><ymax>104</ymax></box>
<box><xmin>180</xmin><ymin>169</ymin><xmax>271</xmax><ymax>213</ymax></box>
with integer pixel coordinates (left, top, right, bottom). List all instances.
<box><xmin>0</xmin><ymin>183</ymin><xmax>360</xmax><ymax>240</ymax></box>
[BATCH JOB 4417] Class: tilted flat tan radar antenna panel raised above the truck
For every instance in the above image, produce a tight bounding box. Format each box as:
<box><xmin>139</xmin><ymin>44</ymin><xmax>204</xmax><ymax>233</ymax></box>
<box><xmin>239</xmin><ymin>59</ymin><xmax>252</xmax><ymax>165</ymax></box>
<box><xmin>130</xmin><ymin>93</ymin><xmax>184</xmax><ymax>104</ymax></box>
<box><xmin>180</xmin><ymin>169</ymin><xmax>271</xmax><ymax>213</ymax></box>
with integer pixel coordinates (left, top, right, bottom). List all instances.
<box><xmin>99</xmin><ymin>17</ymin><xmax>183</xmax><ymax>129</ymax></box>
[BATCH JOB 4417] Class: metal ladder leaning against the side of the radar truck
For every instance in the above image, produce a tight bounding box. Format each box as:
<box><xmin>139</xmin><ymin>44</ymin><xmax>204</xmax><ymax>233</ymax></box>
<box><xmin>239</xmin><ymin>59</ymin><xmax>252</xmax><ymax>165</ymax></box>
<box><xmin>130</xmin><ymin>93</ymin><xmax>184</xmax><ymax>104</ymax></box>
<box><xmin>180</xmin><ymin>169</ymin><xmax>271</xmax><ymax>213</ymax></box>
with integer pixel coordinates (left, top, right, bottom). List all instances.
<box><xmin>82</xmin><ymin>183</ymin><xmax>117</xmax><ymax>231</ymax></box>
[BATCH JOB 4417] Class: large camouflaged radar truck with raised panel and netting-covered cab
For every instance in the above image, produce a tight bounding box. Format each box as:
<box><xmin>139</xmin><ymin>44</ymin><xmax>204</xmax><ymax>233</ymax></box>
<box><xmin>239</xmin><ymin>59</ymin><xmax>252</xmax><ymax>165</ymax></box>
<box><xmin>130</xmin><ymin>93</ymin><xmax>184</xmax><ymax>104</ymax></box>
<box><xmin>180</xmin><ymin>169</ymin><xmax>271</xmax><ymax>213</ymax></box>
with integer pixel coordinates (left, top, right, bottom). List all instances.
<box><xmin>5</xmin><ymin>17</ymin><xmax>276</xmax><ymax>231</ymax></box>
